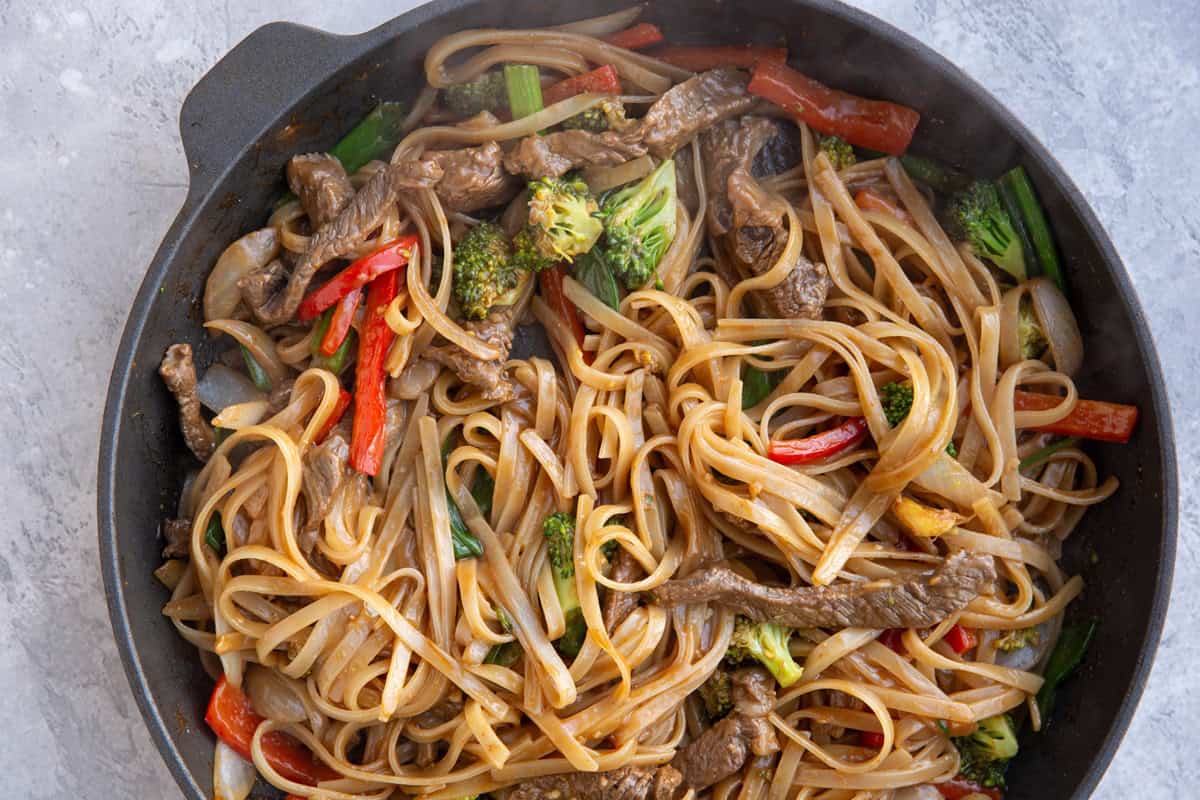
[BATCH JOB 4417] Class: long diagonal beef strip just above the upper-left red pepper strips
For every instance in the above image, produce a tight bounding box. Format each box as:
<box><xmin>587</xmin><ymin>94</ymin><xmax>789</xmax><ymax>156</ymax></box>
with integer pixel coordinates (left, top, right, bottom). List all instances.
<box><xmin>250</xmin><ymin>161</ymin><xmax>442</xmax><ymax>325</ymax></box>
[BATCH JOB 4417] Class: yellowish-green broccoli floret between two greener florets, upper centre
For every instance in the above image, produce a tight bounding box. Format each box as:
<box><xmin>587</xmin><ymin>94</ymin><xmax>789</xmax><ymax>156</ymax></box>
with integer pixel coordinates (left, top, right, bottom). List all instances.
<box><xmin>528</xmin><ymin>178</ymin><xmax>604</xmax><ymax>261</ymax></box>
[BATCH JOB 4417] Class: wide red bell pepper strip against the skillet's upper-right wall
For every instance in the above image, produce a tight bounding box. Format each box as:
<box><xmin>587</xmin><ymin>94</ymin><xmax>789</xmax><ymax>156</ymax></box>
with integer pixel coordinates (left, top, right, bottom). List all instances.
<box><xmin>746</xmin><ymin>59</ymin><xmax>920</xmax><ymax>156</ymax></box>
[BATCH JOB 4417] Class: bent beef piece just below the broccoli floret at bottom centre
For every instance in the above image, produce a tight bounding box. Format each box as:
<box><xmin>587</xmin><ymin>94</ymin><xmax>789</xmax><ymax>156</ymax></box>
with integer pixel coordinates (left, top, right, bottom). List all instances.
<box><xmin>671</xmin><ymin>668</ymin><xmax>779</xmax><ymax>792</ymax></box>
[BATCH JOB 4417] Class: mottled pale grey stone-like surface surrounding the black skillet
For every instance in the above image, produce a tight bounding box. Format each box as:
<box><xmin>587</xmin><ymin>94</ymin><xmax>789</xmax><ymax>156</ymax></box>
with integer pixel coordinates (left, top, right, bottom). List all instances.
<box><xmin>0</xmin><ymin>0</ymin><xmax>1200</xmax><ymax>800</ymax></box>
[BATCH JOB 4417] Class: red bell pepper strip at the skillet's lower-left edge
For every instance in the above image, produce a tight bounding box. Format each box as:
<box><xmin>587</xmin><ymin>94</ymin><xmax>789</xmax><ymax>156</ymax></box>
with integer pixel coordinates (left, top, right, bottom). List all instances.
<box><xmin>204</xmin><ymin>675</ymin><xmax>341</xmax><ymax>786</ymax></box>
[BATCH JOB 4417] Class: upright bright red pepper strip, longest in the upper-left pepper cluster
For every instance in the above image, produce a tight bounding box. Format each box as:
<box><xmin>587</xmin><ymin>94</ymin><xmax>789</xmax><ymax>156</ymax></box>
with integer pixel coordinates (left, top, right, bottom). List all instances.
<box><xmin>350</xmin><ymin>270</ymin><xmax>400</xmax><ymax>475</ymax></box>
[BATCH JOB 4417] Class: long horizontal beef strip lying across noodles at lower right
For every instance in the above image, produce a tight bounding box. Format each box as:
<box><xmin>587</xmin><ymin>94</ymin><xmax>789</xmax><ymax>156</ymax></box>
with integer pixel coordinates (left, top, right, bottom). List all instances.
<box><xmin>654</xmin><ymin>551</ymin><xmax>996</xmax><ymax>628</ymax></box>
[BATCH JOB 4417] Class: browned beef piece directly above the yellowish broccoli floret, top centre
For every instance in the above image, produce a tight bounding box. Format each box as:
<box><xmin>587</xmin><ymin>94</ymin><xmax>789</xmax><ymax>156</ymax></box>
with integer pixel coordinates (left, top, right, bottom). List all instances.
<box><xmin>504</xmin><ymin>130</ymin><xmax>646</xmax><ymax>178</ymax></box>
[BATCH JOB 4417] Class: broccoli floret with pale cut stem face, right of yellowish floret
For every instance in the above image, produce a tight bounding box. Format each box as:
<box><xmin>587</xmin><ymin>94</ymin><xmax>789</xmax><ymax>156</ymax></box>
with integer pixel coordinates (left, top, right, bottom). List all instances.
<box><xmin>600</xmin><ymin>160</ymin><xmax>676</xmax><ymax>289</ymax></box>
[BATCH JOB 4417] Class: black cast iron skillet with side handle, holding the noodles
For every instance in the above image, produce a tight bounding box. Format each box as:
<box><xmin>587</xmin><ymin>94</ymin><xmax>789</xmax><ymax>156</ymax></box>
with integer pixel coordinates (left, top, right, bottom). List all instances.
<box><xmin>98</xmin><ymin>0</ymin><xmax>1177</xmax><ymax>800</ymax></box>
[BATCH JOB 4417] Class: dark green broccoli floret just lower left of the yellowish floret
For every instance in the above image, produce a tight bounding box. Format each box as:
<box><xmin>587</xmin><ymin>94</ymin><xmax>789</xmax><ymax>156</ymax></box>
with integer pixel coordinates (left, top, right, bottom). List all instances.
<box><xmin>454</xmin><ymin>222</ymin><xmax>524</xmax><ymax>319</ymax></box>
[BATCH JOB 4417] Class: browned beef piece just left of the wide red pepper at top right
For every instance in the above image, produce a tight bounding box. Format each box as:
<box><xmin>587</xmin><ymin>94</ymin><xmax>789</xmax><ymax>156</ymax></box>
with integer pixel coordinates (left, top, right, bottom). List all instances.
<box><xmin>641</xmin><ymin>68</ymin><xmax>756</xmax><ymax>158</ymax></box>
